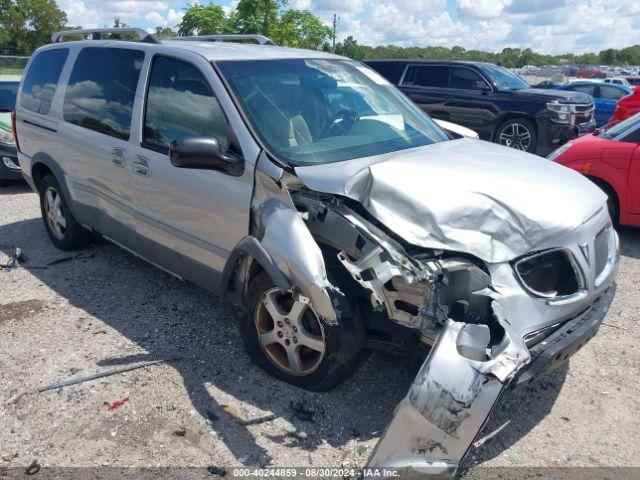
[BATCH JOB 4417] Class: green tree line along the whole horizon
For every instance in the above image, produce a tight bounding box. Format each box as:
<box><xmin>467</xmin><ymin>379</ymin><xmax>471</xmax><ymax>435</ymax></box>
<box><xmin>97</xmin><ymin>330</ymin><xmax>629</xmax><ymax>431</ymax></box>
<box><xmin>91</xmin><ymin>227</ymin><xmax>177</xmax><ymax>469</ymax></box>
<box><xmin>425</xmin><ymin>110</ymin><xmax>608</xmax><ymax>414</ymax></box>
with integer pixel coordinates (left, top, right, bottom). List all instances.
<box><xmin>0</xmin><ymin>0</ymin><xmax>640</xmax><ymax>68</ymax></box>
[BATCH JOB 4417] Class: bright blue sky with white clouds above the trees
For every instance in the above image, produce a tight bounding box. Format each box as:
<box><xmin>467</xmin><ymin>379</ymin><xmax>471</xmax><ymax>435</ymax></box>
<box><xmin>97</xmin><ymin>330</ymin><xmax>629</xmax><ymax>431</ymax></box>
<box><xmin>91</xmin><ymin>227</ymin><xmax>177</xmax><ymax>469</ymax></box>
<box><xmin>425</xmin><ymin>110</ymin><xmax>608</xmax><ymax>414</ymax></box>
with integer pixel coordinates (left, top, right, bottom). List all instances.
<box><xmin>58</xmin><ymin>0</ymin><xmax>640</xmax><ymax>54</ymax></box>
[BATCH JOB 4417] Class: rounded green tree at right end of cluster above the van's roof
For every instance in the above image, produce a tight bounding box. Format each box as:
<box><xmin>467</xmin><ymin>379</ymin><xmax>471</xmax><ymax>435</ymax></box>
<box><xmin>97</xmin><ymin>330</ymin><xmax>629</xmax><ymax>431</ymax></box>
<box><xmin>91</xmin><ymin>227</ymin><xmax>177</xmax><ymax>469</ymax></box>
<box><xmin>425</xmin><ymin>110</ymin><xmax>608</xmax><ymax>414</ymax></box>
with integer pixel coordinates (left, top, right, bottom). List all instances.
<box><xmin>271</xmin><ymin>8</ymin><xmax>332</xmax><ymax>50</ymax></box>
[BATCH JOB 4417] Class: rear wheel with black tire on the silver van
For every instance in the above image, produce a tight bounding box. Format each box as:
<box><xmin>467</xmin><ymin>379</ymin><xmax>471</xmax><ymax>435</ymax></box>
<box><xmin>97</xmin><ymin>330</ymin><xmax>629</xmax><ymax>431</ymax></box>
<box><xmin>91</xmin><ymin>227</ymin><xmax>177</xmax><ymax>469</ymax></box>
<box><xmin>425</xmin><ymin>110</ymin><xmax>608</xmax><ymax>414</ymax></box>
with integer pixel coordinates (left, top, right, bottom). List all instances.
<box><xmin>38</xmin><ymin>174</ymin><xmax>92</xmax><ymax>250</ymax></box>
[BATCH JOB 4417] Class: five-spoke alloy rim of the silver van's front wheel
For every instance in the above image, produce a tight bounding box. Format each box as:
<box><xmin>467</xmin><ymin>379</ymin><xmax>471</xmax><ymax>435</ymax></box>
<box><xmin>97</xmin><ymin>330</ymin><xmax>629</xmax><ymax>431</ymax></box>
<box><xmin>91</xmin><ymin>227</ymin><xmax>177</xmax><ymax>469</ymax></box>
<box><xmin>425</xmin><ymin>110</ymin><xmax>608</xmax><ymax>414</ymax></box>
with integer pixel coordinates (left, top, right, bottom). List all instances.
<box><xmin>255</xmin><ymin>288</ymin><xmax>326</xmax><ymax>376</ymax></box>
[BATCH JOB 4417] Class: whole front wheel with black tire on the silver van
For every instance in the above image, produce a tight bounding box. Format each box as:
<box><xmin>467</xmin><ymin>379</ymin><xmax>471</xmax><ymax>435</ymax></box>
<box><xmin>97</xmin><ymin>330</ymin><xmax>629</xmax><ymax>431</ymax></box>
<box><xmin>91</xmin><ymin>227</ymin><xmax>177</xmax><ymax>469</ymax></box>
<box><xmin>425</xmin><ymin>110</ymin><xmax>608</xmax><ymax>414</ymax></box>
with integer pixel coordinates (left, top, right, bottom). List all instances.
<box><xmin>240</xmin><ymin>272</ymin><xmax>364</xmax><ymax>391</ymax></box>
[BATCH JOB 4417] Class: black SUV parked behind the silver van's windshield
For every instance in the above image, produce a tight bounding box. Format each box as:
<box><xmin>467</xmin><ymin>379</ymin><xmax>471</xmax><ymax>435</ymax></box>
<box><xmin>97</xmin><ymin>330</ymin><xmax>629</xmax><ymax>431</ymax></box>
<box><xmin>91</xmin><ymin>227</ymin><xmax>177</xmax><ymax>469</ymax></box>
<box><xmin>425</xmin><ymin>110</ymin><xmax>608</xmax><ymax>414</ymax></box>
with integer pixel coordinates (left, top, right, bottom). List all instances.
<box><xmin>366</xmin><ymin>60</ymin><xmax>595</xmax><ymax>155</ymax></box>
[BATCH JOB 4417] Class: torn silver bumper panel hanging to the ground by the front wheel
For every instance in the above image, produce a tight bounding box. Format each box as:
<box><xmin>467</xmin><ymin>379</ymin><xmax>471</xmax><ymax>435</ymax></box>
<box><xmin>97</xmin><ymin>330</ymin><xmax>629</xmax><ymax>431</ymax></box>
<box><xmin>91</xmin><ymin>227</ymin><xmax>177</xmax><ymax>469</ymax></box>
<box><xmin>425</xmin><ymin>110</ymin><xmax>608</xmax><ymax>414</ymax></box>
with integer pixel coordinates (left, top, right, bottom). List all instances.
<box><xmin>367</xmin><ymin>320</ymin><xmax>529</xmax><ymax>478</ymax></box>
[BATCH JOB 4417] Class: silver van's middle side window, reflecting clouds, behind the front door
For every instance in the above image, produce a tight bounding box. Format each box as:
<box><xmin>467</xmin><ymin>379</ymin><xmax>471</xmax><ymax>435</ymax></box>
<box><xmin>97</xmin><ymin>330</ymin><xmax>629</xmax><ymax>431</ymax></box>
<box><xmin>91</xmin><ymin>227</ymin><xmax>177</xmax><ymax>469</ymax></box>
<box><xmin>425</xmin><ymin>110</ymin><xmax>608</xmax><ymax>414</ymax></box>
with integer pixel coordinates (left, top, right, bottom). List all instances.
<box><xmin>63</xmin><ymin>47</ymin><xmax>144</xmax><ymax>140</ymax></box>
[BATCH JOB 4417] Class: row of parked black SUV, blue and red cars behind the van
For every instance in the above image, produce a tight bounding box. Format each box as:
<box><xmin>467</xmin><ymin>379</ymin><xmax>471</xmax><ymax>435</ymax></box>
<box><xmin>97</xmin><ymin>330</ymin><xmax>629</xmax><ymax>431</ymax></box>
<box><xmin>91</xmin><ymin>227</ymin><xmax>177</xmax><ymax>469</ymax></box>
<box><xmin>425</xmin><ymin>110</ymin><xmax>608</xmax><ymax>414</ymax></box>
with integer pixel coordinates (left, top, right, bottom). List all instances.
<box><xmin>367</xmin><ymin>60</ymin><xmax>640</xmax><ymax>226</ymax></box>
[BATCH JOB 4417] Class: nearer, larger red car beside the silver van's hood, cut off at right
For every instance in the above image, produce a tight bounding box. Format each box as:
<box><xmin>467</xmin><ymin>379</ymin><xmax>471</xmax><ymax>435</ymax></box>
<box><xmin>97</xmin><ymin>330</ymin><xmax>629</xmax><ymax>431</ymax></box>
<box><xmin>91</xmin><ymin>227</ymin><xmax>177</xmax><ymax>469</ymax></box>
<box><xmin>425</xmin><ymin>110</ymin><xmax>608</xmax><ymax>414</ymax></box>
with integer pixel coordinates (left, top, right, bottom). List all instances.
<box><xmin>547</xmin><ymin>113</ymin><xmax>640</xmax><ymax>227</ymax></box>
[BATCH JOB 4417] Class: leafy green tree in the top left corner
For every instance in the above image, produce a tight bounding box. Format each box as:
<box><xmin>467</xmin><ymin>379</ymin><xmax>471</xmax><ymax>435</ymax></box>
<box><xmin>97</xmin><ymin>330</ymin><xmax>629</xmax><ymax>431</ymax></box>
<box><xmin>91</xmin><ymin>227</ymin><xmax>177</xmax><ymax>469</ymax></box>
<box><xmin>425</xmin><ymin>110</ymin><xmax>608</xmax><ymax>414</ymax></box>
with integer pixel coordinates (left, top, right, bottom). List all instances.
<box><xmin>0</xmin><ymin>0</ymin><xmax>67</xmax><ymax>52</ymax></box>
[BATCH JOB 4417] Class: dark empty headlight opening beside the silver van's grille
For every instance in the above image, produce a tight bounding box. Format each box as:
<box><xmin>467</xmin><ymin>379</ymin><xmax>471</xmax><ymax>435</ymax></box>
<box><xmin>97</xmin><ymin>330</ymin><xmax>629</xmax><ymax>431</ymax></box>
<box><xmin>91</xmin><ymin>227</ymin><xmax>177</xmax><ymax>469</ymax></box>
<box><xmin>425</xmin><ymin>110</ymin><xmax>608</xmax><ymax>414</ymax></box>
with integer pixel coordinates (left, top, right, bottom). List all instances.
<box><xmin>514</xmin><ymin>249</ymin><xmax>584</xmax><ymax>298</ymax></box>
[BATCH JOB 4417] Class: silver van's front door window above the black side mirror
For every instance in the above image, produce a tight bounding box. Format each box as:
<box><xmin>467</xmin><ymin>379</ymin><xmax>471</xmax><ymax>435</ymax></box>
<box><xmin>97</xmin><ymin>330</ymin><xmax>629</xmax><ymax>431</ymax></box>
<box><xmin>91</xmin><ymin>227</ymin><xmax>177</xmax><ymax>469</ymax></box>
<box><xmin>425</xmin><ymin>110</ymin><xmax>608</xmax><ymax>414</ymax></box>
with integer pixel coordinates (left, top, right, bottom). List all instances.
<box><xmin>143</xmin><ymin>57</ymin><xmax>229</xmax><ymax>152</ymax></box>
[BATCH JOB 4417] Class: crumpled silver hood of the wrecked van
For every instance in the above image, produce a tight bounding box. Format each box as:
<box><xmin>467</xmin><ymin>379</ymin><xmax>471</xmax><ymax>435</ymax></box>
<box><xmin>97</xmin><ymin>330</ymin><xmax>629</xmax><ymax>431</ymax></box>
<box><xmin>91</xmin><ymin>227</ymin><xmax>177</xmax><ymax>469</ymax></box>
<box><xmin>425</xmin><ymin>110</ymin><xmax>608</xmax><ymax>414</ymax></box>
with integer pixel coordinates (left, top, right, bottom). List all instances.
<box><xmin>295</xmin><ymin>138</ymin><xmax>606</xmax><ymax>263</ymax></box>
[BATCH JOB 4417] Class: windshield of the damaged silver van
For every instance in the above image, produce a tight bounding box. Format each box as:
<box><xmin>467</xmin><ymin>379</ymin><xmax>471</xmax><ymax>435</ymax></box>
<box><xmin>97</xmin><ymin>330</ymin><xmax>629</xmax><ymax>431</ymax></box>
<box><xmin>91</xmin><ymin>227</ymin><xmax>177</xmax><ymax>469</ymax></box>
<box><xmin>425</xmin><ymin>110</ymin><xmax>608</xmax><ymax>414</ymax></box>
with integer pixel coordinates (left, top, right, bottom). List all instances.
<box><xmin>218</xmin><ymin>59</ymin><xmax>448</xmax><ymax>165</ymax></box>
